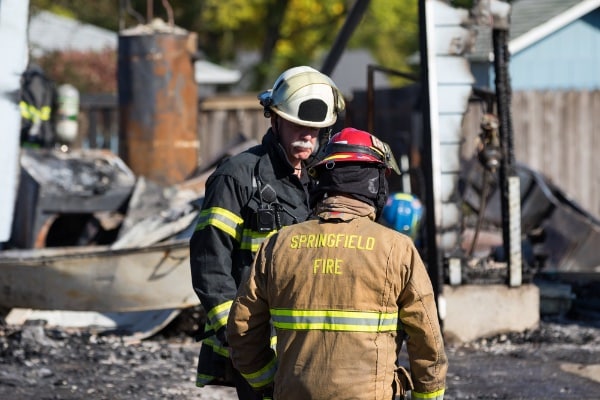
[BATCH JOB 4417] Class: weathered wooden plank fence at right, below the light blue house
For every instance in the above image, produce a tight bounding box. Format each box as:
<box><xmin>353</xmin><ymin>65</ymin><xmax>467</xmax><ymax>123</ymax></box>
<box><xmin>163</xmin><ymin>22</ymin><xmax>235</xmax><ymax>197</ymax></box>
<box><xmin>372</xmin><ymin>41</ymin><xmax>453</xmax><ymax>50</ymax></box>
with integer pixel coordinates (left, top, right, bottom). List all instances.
<box><xmin>462</xmin><ymin>90</ymin><xmax>600</xmax><ymax>218</ymax></box>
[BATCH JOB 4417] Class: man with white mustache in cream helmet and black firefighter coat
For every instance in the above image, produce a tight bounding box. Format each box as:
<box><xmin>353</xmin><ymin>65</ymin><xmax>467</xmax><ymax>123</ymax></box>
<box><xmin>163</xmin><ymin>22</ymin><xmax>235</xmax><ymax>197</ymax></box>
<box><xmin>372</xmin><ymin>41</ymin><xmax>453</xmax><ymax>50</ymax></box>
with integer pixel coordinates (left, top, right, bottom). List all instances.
<box><xmin>190</xmin><ymin>66</ymin><xmax>344</xmax><ymax>400</ymax></box>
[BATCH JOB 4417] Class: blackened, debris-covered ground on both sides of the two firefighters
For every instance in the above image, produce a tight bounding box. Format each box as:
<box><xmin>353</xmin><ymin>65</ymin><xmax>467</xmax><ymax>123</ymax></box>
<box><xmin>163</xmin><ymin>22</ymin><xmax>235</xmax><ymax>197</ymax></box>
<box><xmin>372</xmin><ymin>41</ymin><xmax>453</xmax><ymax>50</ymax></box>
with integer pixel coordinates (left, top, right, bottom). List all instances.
<box><xmin>0</xmin><ymin>310</ymin><xmax>600</xmax><ymax>400</ymax></box>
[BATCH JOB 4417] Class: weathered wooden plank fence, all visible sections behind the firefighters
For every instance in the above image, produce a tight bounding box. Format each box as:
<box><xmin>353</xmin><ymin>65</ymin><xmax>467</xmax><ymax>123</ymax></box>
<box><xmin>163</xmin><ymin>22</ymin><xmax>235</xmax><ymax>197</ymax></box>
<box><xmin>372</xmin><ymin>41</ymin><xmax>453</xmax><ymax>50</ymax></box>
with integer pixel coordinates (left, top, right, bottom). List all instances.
<box><xmin>76</xmin><ymin>91</ymin><xmax>600</xmax><ymax>217</ymax></box>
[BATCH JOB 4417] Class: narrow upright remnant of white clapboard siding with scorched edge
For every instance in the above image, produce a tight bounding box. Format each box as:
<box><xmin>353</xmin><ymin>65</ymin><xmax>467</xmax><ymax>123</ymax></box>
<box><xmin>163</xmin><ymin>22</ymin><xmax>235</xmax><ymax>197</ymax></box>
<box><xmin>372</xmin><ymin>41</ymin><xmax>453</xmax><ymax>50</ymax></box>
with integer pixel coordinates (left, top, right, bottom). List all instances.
<box><xmin>425</xmin><ymin>0</ymin><xmax>475</xmax><ymax>252</ymax></box>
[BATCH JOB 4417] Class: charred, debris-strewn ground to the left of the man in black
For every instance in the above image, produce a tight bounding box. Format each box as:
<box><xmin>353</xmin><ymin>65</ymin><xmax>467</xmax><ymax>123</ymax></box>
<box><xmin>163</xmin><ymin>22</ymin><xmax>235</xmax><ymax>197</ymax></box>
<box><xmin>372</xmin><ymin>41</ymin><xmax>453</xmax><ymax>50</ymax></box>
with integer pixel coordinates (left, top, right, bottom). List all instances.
<box><xmin>0</xmin><ymin>310</ymin><xmax>236</xmax><ymax>400</ymax></box>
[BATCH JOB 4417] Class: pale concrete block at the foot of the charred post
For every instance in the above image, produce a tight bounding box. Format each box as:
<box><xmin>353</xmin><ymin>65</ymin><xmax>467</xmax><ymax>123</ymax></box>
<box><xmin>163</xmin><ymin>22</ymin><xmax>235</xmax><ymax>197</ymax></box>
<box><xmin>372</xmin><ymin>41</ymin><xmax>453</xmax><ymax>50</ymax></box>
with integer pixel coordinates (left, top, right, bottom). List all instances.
<box><xmin>440</xmin><ymin>284</ymin><xmax>540</xmax><ymax>343</ymax></box>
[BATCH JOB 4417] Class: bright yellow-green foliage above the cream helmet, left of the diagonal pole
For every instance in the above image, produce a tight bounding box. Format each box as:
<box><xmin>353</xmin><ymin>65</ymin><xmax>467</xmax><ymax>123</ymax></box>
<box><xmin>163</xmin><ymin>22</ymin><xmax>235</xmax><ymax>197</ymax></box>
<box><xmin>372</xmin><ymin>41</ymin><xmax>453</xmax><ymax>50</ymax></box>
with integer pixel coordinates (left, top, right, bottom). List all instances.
<box><xmin>178</xmin><ymin>0</ymin><xmax>348</xmax><ymax>90</ymax></box>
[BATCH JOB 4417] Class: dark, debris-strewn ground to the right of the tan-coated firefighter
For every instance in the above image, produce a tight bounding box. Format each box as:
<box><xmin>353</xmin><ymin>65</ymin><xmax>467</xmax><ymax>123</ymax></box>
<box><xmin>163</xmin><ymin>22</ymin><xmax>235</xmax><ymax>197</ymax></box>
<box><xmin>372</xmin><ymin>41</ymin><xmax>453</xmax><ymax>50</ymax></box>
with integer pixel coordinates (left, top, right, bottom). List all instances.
<box><xmin>444</xmin><ymin>317</ymin><xmax>600</xmax><ymax>400</ymax></box>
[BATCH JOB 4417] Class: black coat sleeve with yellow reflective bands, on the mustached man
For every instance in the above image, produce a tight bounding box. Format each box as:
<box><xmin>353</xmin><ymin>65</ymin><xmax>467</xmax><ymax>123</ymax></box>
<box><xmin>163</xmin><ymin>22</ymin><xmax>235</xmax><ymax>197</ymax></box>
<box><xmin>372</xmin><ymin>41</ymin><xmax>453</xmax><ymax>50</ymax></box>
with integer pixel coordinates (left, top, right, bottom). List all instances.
<box><xmin>190</xmin><ymin>175</ymin><xmax>247</xmax><ymax>332</ymax></box>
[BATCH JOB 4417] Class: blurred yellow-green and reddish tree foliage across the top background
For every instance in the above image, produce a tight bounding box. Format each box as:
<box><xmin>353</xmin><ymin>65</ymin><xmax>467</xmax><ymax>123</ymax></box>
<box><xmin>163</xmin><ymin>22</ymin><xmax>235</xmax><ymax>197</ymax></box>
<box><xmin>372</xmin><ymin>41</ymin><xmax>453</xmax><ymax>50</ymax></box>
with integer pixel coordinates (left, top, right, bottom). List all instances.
<box><xmin>31</xmin><ymin>0</ymin><xmax>418</xmax><ymax>91</ymax></box>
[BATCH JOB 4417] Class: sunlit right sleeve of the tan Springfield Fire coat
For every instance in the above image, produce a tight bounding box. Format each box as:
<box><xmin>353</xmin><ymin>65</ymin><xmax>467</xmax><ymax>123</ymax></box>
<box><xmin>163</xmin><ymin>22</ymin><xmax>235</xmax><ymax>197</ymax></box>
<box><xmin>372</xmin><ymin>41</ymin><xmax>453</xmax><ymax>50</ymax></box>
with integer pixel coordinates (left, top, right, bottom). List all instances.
<box><xmin>398</xmin><ymin>242</ymin><xmax>448</xmax><ymax>400</ymax></box>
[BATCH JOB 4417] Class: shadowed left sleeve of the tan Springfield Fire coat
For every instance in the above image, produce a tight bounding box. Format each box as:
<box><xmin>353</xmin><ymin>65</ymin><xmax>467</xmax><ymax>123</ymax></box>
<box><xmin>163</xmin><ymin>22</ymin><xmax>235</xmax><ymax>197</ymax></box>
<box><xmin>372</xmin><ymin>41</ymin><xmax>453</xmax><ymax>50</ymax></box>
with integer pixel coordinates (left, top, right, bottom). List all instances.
<box><xmin>227</xmin><ymin>240</ymin><xmax>277</xmax><ymax>390</ymax></box>
